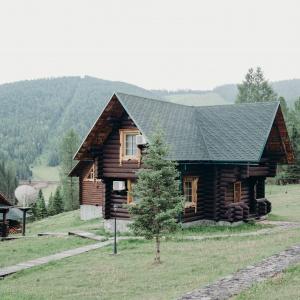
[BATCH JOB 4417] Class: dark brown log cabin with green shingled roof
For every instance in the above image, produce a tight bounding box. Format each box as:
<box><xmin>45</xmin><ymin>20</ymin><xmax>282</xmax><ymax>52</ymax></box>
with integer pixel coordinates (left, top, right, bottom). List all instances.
<box><xmin>70</xmin><ymin>93</ymin><xmax>294</xmax><ymax>222</ymax></box>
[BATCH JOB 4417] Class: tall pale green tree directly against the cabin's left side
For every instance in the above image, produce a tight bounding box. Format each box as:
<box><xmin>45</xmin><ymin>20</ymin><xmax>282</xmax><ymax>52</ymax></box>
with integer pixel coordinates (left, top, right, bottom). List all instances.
<box><xmin>59</xmin><ymin>129</ymin><xmax>79</xmax><ymax>211</ymax></box>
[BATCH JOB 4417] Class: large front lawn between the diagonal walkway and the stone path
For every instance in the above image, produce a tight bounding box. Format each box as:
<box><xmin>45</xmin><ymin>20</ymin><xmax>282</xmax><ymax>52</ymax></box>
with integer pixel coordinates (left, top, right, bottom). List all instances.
<box><xmin>0</xmin><ymin>230</ymin><xmax>300</xmax><ymax>300</ymax></box>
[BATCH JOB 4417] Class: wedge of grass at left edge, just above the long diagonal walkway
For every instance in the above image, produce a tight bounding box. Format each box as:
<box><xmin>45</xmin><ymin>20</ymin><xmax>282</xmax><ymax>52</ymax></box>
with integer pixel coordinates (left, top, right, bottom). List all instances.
<box><xmin>0</xmin><ymin>236</ymin><xmax>91</xmax><ymax>268</ymax></box>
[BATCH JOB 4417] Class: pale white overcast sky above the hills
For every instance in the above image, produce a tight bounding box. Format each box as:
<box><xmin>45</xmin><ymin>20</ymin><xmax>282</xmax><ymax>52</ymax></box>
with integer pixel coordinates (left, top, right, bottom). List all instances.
<box><xmin>0</xmin><ymin>0</ymin><xmax>300</xmax><ymax>89</ymax></box>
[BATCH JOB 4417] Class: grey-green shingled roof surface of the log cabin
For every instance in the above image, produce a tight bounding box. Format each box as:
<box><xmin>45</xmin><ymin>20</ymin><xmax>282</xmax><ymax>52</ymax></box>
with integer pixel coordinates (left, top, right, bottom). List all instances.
<box><xmin>115</xmin><ymin>93</ymin><xmax>279</xmax><ymax>162</ymax></box>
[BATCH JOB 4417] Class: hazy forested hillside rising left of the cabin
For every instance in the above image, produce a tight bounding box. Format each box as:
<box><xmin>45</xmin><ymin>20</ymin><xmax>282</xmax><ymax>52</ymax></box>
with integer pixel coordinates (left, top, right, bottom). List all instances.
<box><xmin>0</xmin><ymin>77</ymin><xmax>153</xmax><ymax>179</ymax></box>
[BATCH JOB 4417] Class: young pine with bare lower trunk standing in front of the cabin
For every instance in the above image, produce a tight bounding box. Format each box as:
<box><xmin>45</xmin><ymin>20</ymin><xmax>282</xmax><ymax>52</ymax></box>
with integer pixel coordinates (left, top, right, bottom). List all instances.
<box><xmin>129</xmin><ymin>131</ymin><xmax>184</xmax><ymax>263</ymax></box>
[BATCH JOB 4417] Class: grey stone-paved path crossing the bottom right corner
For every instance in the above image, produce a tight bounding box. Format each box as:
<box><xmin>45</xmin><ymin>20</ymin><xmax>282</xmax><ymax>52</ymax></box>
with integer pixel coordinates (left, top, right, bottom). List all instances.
<box><xmin>179</xmin><ymin>245</ymin><xmax>300</xmax><ymax>300</ymax></box>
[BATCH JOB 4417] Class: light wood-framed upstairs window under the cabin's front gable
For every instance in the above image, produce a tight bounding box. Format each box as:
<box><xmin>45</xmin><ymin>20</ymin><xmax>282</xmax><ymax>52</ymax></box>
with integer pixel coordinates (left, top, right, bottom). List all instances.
<box><xmin>120</xmin><ymin>129</ymin><xmax>140</xmax><ymax>164</ymax></box>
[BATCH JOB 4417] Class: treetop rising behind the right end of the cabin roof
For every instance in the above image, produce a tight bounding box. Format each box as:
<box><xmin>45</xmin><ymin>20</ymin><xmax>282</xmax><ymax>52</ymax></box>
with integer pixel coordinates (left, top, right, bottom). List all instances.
<box><xmin>236</xmin><ymin>67</ymin><xmax>277</xmax><ymax>103</ymax></box>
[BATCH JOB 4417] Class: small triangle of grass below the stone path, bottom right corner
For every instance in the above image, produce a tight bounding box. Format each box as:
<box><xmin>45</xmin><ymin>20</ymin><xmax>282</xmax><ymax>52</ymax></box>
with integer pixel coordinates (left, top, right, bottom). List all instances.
<box><xmin>234</xmin><ymin>265</ymin><xmax>300</xmax><ymax>300</ymax></box>
